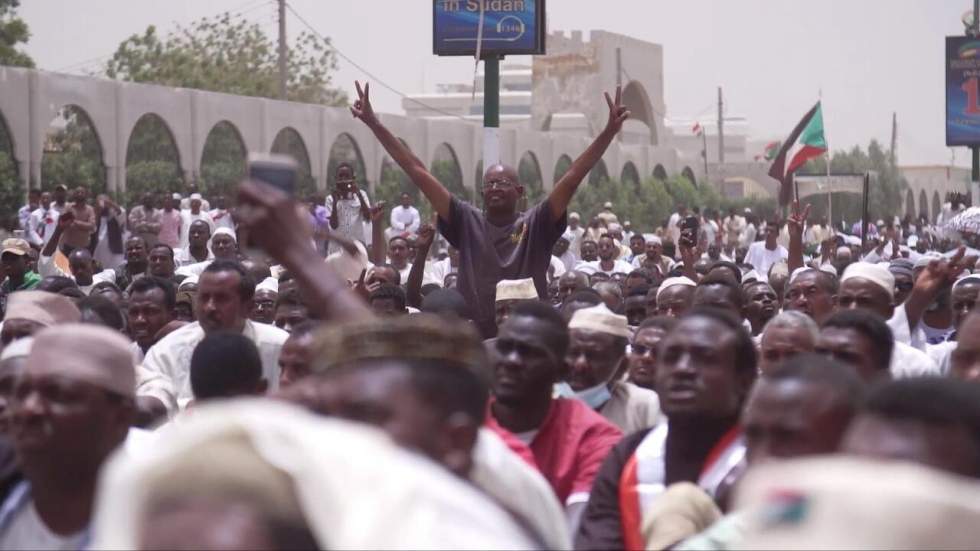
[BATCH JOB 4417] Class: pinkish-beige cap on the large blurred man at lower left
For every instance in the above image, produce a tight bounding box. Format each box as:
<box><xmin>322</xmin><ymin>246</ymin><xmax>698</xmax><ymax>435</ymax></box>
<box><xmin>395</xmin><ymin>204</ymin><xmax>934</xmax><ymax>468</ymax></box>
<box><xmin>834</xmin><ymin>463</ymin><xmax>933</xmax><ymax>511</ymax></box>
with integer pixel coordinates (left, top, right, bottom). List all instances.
<box><xmin>24</xmin><ymin>323</ymin><xmax>136</xmax><ymax>396</ymax></box>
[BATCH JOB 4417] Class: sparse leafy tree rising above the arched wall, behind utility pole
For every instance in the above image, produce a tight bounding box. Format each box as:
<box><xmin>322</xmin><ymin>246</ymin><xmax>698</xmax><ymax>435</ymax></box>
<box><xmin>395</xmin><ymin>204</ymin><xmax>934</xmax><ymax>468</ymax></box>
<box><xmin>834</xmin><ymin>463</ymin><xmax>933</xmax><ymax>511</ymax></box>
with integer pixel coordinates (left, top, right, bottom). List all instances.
<box><xmin>105</xmin><ymin>13</ymin><xmax>347</xmax><ymax>105</ymax></box>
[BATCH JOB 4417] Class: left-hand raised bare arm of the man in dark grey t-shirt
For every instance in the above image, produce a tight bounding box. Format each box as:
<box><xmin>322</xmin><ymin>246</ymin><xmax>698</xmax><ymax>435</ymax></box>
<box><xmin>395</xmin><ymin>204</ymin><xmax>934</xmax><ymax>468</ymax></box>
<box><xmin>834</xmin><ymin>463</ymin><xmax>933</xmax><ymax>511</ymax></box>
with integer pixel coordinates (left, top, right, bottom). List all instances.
<box><xmin>350</xmin><ymin>82</ymin><xmax>452</xmax><ymax>220</ymax></box>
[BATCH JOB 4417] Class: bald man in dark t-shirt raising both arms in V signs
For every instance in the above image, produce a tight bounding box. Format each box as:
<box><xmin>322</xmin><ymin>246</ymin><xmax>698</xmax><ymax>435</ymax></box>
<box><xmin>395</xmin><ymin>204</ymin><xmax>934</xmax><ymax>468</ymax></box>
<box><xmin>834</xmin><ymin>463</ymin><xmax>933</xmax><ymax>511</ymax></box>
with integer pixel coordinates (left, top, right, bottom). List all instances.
<box><xmin>351</xmin><ymin>77</ymin><xmax>629</xmax><ymax>337</ymax></box>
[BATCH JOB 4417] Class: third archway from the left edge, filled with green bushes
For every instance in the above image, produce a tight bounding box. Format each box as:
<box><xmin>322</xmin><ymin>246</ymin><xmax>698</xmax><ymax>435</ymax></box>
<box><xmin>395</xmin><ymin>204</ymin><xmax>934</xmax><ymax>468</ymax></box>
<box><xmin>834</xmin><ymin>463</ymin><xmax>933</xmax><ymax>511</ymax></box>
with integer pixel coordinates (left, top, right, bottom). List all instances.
<box><xmin>126</xmin><ymin>113</ymin><xmax>184</xmax><ymax>203</ymax></box>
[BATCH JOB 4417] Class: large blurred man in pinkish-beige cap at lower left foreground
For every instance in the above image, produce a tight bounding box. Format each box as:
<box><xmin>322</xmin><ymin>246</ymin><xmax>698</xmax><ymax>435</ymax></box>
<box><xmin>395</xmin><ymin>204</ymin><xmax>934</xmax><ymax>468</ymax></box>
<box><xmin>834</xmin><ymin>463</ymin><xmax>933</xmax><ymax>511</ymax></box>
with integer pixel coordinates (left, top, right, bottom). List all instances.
<box><xmin>0</xmin><ymin>324</ymin><xmax>136</xmax><ymax>549</ymax></box>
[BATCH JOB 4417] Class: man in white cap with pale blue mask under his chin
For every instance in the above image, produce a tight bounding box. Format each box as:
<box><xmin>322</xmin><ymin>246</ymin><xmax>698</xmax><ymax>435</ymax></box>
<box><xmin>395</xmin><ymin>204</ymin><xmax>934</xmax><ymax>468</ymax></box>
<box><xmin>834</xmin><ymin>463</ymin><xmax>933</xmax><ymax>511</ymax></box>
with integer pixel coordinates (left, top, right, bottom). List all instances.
<box><xmin>567</xmin><ymin>304</ymin><xmax>660</xmax><ymax>434</ymax></box>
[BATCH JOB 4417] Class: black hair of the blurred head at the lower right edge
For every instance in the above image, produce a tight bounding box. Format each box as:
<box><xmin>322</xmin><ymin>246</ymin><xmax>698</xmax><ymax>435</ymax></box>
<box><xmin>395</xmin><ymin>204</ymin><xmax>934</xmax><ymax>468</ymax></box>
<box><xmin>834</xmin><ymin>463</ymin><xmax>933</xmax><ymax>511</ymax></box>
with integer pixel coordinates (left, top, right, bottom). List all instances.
<box><xmin>862</xmin><ymin>377</ymin><xmax>980</xmax><ymax>476</ymax></box>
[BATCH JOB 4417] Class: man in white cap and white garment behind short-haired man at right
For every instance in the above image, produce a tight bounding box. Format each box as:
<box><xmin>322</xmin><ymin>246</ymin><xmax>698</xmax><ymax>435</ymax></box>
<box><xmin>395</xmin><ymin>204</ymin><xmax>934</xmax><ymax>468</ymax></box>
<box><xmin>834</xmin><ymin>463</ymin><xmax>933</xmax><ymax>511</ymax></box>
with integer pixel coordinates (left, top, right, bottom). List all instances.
<box><xmin>837</xmin><ymin>262</ymin><xmax>939</xmax><ymax>378</ymax></box>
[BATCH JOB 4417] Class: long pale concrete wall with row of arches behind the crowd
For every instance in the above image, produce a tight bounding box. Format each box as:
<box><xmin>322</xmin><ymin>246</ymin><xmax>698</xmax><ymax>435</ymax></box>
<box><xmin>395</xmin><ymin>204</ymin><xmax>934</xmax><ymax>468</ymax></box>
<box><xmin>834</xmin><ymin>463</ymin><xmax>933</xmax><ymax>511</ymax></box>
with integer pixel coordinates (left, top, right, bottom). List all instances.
<box><xmin>0</xmin><ymin>66</ymin><xmax>696</xmax><ymax>201</ymax></box>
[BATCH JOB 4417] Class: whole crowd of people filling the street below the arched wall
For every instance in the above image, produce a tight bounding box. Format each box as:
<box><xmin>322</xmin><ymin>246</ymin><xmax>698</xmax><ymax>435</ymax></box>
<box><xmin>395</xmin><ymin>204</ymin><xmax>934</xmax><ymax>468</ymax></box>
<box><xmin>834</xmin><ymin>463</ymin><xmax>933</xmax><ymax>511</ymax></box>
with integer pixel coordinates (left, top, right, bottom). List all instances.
<box><xmin>0</xmin><ymin>80</ymin><xmax>980</xmax><ymax>549</ymax></box>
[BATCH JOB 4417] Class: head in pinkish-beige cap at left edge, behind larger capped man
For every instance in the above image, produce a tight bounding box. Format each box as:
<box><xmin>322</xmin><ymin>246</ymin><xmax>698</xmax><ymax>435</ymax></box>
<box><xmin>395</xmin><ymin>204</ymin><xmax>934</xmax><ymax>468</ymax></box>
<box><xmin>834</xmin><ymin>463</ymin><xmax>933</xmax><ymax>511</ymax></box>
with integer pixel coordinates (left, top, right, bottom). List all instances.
<box><xmin>0</xmin><ymin>291</ymin><xmax>82</xmax><ymax>346</ymax></box>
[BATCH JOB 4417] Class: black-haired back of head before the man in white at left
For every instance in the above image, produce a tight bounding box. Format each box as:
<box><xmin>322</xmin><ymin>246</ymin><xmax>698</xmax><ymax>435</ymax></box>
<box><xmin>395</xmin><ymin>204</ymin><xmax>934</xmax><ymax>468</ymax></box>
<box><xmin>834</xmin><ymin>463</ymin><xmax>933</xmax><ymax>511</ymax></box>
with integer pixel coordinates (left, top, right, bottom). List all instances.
<box><xmin>190</xmin><ymin>331</ymin><xmax>262</xmax><ymax>400</ymax></box>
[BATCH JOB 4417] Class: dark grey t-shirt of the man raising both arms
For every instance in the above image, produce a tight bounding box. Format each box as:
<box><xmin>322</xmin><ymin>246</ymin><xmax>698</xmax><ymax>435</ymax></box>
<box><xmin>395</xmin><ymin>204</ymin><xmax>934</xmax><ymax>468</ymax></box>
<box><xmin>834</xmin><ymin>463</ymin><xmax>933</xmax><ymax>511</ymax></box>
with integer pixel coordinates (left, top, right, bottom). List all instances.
<box><xmin>439</xmin><ymin>197</ymin><xmax>567</xmax><ymax>338</ymax></box>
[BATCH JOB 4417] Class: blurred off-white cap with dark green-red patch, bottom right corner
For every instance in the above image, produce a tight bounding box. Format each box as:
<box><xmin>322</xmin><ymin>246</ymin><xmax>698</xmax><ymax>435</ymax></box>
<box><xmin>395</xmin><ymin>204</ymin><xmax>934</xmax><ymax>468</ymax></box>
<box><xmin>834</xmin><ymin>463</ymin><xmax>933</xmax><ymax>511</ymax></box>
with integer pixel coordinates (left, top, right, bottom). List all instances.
<box><xmin>732</xmin><ymin>456</ymin><xmax>980</xmax><ymax>549</ymax></box>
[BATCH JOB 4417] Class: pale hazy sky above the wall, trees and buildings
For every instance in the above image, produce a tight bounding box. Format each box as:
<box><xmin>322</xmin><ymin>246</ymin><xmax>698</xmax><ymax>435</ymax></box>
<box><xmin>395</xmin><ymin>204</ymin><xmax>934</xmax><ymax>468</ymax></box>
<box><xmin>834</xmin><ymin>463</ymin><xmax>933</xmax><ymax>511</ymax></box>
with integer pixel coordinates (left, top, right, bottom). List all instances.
<box><xmin>15</xmin><ymin>0</ymin><xmax>972</xmax><ymax>165</ymax></box>
